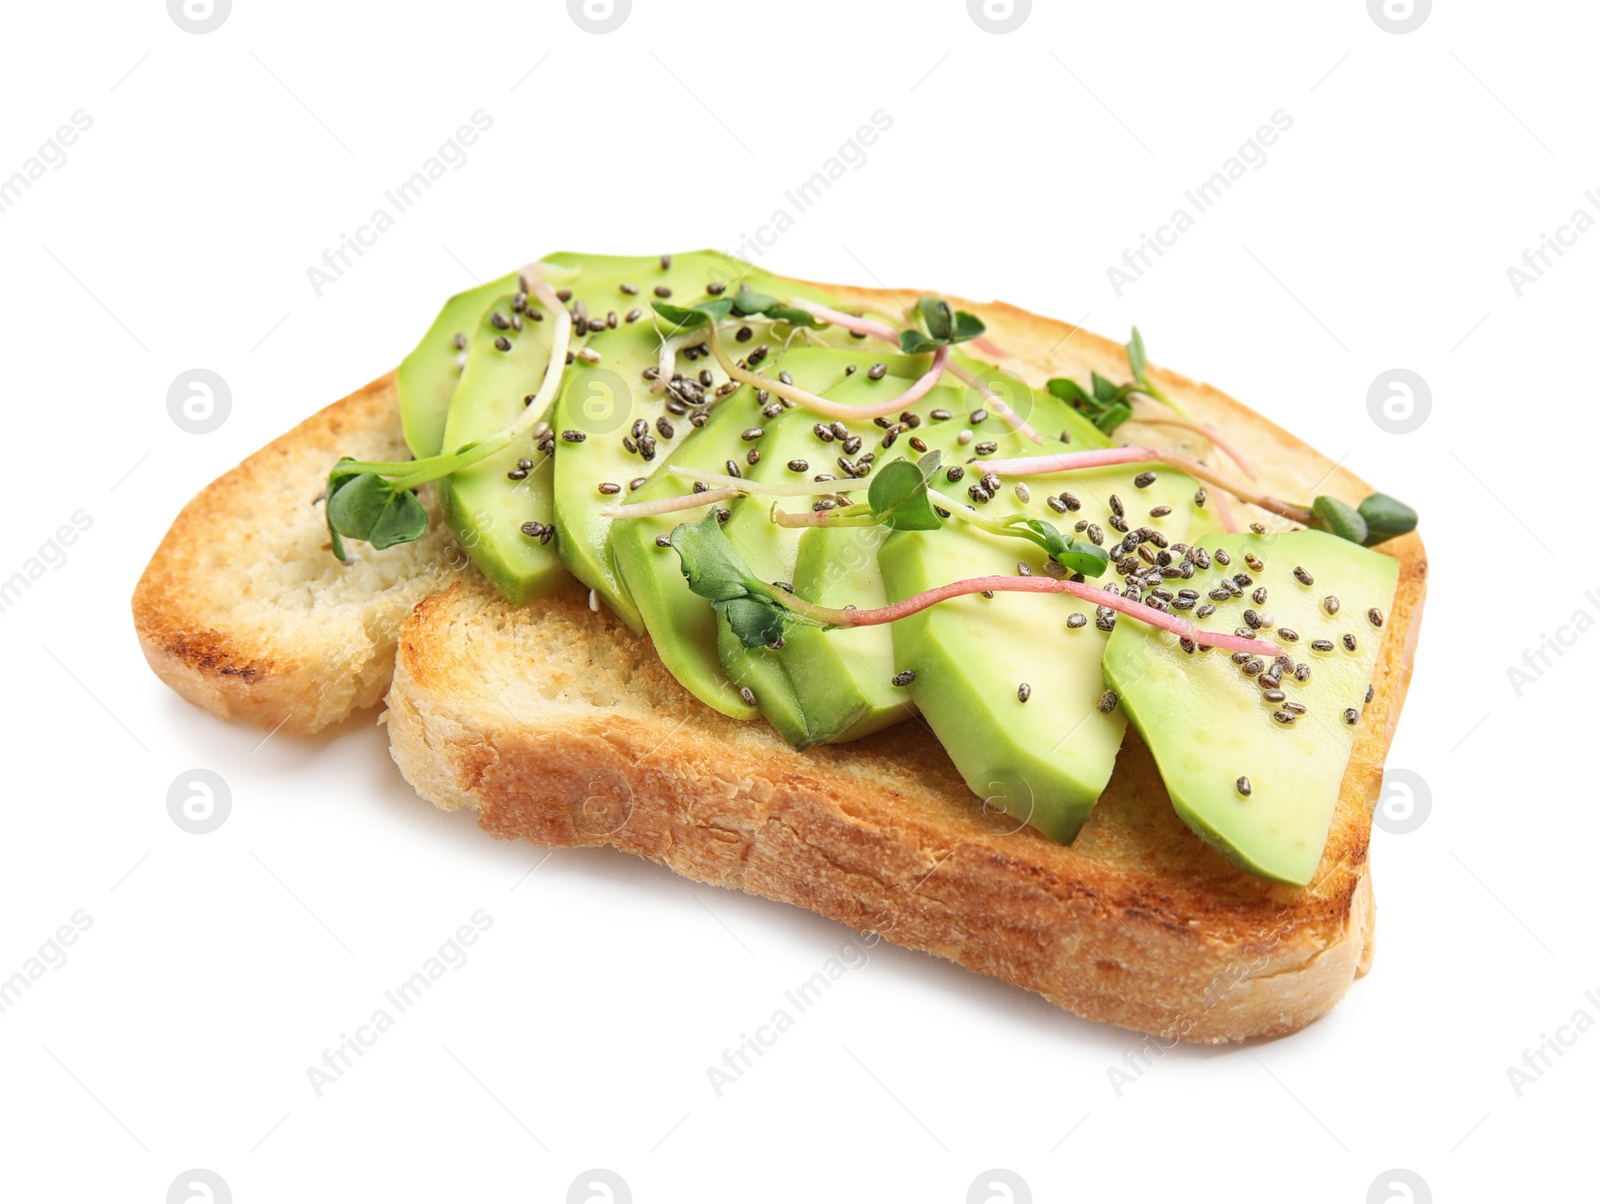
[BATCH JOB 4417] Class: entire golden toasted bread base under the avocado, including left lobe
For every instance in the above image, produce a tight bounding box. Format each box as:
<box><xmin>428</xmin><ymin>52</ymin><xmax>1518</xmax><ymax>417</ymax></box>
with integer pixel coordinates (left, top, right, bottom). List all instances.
<box><xmin>134</xmin><ymin>276</ymin><xmax>1427</xmax><ymax>1042</ymax></box>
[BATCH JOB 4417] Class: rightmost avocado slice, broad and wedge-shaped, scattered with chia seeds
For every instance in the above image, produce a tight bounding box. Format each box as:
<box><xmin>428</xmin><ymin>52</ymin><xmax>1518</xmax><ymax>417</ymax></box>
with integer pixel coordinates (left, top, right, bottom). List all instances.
<box><xmin>1106</xmin><ymin>530</ymin><xmax>1400</xmax><ymax>887</ymax></box>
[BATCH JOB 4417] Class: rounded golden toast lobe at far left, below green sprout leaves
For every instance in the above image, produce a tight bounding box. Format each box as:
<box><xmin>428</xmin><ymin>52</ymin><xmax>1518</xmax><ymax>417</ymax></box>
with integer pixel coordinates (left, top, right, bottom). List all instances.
<box><xmin>133</xmin><ymin>373</ymin><xmax>470</xmax><ymax>733</ymax></box>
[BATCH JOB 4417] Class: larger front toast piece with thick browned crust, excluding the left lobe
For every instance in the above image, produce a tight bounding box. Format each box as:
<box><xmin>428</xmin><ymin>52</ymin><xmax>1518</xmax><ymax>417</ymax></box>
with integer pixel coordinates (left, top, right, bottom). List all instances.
<box><xmin>387</xmin><ymin>288</ymin><xmax>1427</xmax><ymax>1042</ymax></box>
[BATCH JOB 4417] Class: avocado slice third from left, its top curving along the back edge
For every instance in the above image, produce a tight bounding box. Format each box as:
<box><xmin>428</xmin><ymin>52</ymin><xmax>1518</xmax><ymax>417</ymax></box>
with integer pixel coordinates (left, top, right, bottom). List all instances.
<box><xmin>552</xmin><ymin>251</ymin><xmax>813</xmax><ymax>631</ymax></box>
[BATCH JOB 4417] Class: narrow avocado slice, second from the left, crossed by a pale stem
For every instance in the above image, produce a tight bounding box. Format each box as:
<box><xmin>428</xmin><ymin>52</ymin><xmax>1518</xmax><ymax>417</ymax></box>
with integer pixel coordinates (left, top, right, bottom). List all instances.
<box><xmin>438</xmin><ymin>296</ymin><xmax>562</xmax><ymax>605</ymax></box>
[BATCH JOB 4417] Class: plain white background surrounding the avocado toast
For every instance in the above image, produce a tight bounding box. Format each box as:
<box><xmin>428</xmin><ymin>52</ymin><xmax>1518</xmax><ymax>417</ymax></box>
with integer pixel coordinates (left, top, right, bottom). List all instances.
<box><xmin>0</xmin><ymin>0</ymin><xmax>1600</xmax><ymax>1204</ymax></box>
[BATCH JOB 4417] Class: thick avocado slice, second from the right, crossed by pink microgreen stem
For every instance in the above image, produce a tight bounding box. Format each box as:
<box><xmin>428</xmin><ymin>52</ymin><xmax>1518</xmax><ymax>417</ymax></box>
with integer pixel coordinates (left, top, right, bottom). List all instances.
<box><xmin>878</xmin><ymin>454</ymin><xmax>1195</xmax><ymax>842</ymax></box>
